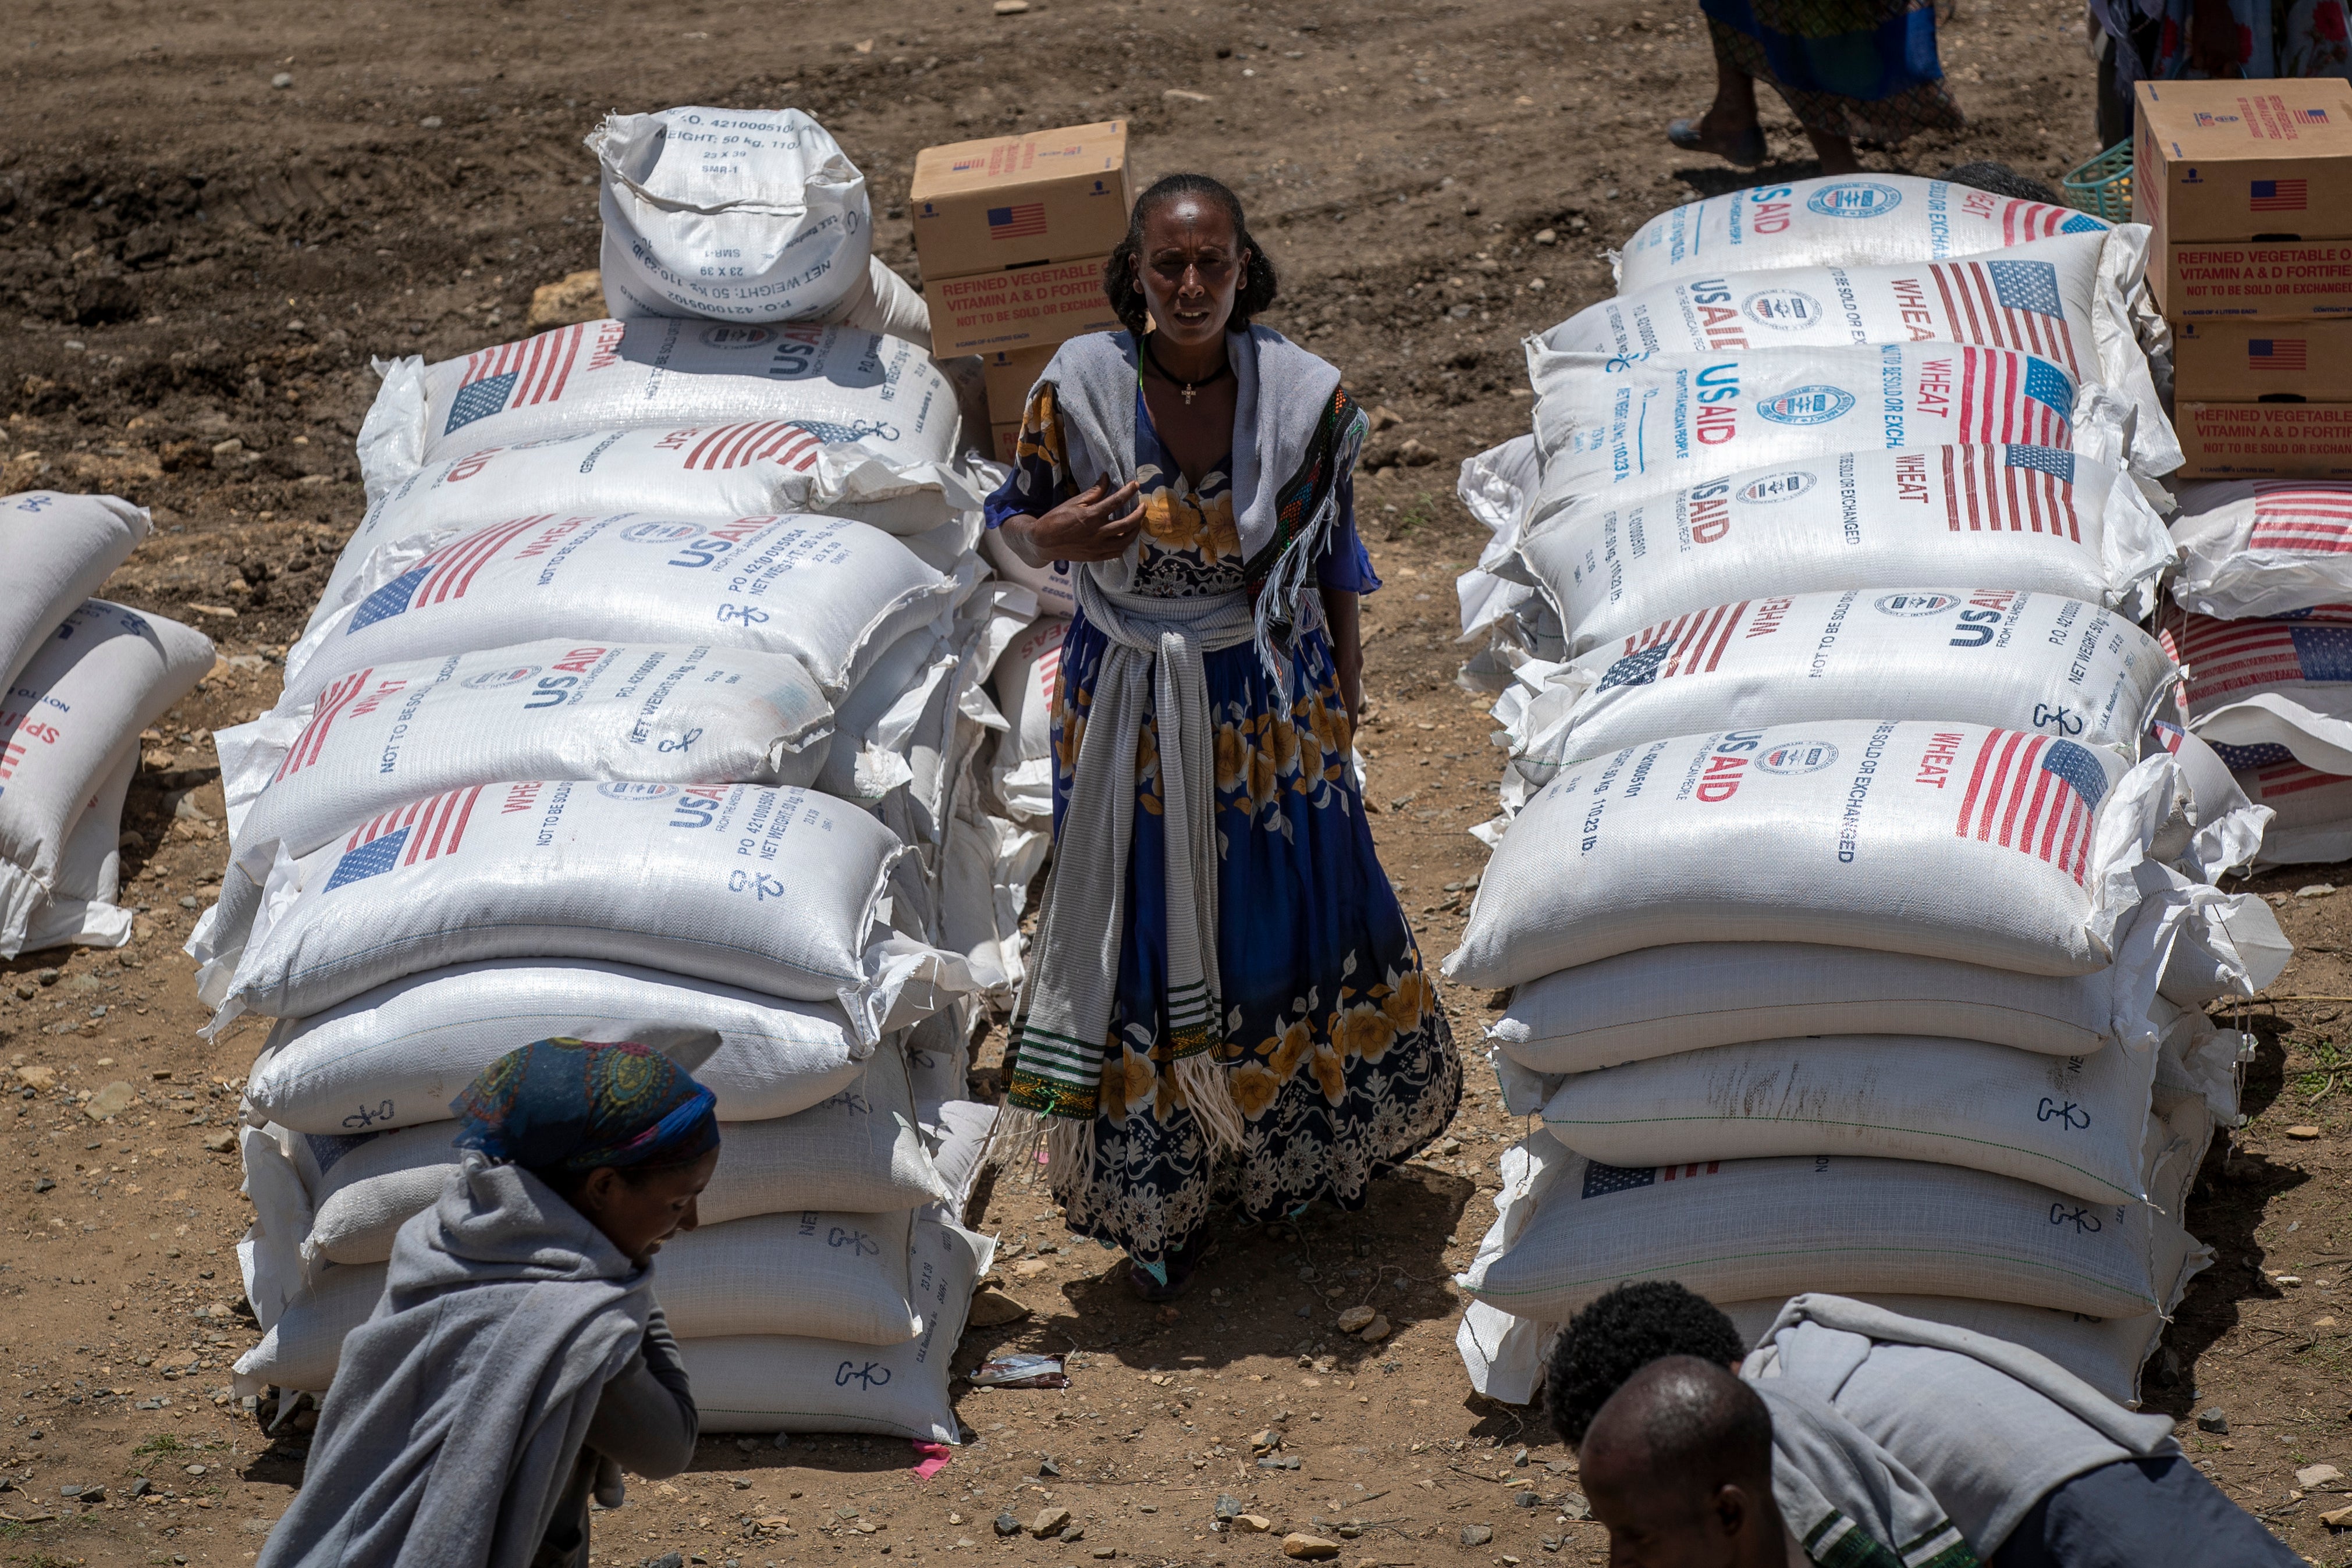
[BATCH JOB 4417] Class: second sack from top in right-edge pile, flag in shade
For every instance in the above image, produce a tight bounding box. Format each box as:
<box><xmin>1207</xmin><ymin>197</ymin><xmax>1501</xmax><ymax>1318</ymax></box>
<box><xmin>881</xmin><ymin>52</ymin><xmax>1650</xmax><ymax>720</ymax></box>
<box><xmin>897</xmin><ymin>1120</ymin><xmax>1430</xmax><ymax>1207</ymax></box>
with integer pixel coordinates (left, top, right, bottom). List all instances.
<box><xmin>2164</xmin><ymin>611</ymin><xmax>2352</xmax><ymax>773</ymax></box>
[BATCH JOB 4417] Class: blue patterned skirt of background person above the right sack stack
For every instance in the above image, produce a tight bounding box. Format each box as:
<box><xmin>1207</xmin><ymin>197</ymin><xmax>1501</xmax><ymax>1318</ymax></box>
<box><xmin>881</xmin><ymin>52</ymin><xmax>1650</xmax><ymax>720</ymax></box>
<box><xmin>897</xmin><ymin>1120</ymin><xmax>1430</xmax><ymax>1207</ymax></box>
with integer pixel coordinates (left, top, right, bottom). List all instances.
<box><xmin>1700</xmin><ymin>0</ymin><xmax>1966</xmax><ymax>146</ymax></box>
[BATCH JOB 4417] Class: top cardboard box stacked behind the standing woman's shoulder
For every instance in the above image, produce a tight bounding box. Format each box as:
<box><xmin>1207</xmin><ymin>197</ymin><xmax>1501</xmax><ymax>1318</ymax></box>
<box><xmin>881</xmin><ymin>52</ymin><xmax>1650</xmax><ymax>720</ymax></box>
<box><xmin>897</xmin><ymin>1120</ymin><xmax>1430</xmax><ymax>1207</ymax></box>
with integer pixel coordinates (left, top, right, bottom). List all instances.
<box><xmin>908</xmin><ymin>120</ymin><xmax>1136</xmax><ymax>285</ymax></box>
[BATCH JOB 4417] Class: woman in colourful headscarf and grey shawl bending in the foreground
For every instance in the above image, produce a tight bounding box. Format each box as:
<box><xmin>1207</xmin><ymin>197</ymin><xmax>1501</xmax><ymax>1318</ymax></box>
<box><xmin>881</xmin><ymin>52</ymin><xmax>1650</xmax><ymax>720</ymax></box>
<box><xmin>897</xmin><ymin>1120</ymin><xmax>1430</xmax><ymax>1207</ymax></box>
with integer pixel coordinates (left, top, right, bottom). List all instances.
<box><xmin>257</xmin><ymin>1039</ymin><xmax>720</xmax><ymax>1568</ymax></box>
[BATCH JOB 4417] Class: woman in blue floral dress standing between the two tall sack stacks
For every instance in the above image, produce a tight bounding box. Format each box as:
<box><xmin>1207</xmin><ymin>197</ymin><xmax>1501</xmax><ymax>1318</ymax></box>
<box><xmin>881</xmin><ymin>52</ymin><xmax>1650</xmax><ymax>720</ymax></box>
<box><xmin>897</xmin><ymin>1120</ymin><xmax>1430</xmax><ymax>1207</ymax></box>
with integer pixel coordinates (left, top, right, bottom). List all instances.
<box><xmin>988</xmin><ymin>174</ymin><xmax>1461</xmax><ymax>1300</ymax></box>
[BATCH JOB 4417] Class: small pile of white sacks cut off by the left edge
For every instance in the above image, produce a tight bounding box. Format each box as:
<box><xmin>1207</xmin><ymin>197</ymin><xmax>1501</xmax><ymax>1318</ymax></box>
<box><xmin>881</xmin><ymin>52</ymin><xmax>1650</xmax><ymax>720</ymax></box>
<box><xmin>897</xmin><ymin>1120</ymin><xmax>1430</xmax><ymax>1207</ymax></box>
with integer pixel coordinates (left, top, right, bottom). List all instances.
<box><xmin>0</xmin><ymin>489</ymin><xmax>214</xmax><ymax>959</ymax></box>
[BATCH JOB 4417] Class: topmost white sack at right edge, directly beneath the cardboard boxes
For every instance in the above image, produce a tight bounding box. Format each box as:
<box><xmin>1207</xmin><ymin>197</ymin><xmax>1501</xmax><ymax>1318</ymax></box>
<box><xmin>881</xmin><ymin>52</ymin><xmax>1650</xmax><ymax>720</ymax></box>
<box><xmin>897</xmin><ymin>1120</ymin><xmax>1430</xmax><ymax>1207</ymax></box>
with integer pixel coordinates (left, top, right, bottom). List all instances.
<box><xmin>2173</xmin><ymin>479</ymin><xmax>2352</xmax><ymax>621</ymax></box>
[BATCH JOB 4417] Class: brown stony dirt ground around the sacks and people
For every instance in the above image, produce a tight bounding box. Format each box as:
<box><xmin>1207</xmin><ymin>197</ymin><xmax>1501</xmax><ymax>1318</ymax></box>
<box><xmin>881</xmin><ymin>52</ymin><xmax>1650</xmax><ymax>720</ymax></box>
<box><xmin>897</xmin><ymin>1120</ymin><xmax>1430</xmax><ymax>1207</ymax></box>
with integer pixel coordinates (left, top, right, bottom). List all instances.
<box><xmin>0</xmin><ymin>0</ymin><xmax>2352</xmax><ymax>1568</ymax></box>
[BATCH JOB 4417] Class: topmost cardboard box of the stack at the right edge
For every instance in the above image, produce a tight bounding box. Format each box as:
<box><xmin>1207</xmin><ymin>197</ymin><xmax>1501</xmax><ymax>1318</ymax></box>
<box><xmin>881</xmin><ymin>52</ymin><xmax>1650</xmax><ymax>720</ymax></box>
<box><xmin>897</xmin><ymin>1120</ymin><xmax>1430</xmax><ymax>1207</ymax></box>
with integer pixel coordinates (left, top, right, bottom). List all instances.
<box><xmin>2131</xmin><ymin>77</ymin><xmax>2352</xmax><ymax>254</ymax></box>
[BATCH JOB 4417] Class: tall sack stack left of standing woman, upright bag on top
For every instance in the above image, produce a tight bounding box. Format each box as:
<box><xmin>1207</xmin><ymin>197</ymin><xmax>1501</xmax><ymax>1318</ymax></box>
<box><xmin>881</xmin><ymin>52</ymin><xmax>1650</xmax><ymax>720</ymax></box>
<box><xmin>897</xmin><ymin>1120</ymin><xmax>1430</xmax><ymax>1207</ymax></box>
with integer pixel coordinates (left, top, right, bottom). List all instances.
<box><xmin>190</xmin><ymin>108</ymin><xmax>1035</xmax><ymax>1441</ymax></box>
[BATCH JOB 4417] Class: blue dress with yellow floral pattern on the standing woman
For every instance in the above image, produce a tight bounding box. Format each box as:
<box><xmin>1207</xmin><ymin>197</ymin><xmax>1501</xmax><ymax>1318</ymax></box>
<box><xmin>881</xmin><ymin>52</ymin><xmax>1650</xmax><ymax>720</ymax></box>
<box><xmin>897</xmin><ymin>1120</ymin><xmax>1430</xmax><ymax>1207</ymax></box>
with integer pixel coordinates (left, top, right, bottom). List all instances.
<box><xmin>988</xmin><ymin>386</ymin><xmax>1461</xmax><ymax>1279</ymax></box>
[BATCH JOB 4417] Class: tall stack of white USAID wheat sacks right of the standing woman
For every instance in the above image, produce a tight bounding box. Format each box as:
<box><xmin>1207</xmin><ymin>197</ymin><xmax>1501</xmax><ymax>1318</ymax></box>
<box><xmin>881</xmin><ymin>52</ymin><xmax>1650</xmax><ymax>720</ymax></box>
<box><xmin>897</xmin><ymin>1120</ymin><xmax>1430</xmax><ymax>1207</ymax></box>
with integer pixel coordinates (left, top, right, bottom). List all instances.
<box><xmin>1447</xmin><ymin>176</ymin><xmax>2284</xmax><ymax>1401</ymax></box>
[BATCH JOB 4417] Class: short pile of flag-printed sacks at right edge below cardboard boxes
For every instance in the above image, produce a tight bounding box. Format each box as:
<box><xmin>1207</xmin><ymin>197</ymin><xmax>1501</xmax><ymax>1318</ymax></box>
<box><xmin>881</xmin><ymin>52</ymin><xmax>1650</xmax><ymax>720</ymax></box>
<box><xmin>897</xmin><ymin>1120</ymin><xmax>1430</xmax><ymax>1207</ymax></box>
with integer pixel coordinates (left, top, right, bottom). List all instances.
<box><xmin>2162</xmin><ymin>479</ymin><xmax>2352</xmax><ymax>865</ymax></box>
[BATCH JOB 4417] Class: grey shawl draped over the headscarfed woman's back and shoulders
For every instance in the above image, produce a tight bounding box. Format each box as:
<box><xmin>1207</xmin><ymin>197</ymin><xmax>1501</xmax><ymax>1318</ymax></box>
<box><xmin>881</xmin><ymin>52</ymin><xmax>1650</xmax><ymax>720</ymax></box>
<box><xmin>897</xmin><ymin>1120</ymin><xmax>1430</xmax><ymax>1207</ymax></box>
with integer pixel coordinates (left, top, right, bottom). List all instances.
<box><xmin>257</xmin><ymin>1154</ymin><xmax>654</xmax><ymax>1568</ymax></box>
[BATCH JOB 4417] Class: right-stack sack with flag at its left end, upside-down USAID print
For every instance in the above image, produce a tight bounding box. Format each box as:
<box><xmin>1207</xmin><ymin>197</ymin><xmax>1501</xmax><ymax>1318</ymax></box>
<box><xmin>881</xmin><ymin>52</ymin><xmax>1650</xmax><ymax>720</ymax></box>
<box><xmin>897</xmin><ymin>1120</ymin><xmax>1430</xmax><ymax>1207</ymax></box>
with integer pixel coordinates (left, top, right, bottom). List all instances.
<box><xmin>1494</xmin><ymin>588</ymin><xmax>2173</xmax><ymax>804</ymax></box>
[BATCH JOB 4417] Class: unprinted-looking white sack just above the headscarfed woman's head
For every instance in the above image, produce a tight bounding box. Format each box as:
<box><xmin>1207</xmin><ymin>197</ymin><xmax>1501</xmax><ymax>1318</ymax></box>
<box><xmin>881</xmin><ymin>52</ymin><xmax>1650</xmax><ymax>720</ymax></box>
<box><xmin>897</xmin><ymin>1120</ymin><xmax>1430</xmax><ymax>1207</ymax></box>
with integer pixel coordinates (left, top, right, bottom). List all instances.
<box><xmin>244</xmin><ymin>959</ymin><xmax>871</xmax><ymax>1133</ymax></box>
